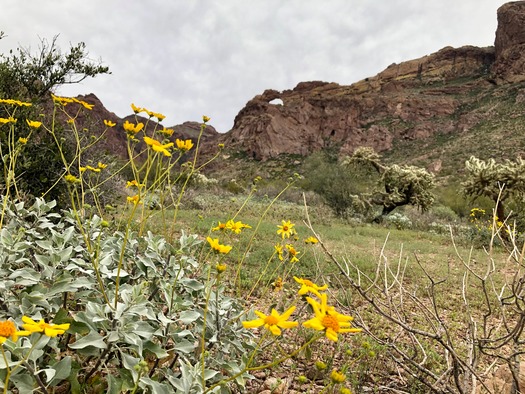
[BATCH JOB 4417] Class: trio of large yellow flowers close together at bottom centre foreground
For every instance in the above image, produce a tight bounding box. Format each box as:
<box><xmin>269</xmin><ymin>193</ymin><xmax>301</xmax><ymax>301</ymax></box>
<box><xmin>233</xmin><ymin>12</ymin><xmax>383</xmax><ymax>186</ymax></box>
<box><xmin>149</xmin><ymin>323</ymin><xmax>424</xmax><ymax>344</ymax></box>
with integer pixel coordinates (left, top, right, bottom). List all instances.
<box><xmin>242</xmin><ymin>277</ymin><xmax>361</xmax><ymax>341</ymax></box>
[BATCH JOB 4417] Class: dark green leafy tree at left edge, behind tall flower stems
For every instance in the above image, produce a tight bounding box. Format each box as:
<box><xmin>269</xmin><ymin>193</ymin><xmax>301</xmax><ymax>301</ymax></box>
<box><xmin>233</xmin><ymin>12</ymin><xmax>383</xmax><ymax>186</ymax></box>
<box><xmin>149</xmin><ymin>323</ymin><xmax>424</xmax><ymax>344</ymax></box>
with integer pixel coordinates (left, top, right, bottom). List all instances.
<box><xmin>0</xmin><ymin>34</ymin><xmax>109</xmax><ymax>203</ymax></box>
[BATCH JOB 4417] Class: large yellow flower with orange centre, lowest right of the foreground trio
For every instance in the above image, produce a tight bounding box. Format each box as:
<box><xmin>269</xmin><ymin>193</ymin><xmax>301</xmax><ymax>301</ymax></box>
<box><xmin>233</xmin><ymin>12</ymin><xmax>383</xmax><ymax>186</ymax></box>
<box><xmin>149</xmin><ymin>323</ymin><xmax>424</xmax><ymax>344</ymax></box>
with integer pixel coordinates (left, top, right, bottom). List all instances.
<box><xmin>303</xmin><ymin>293</ymin><xmax>361</xmax><ymax>342</ymax></box>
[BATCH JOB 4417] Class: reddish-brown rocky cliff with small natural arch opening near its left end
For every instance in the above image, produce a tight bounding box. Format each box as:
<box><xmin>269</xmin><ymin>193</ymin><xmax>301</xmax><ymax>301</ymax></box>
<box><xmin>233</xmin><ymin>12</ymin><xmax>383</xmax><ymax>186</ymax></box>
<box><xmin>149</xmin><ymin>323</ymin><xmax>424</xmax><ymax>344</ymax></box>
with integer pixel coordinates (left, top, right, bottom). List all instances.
<box><xmin>219</xmin><ymin>1</ymin><xmax>525</xmax><ymax>160</ymax></box>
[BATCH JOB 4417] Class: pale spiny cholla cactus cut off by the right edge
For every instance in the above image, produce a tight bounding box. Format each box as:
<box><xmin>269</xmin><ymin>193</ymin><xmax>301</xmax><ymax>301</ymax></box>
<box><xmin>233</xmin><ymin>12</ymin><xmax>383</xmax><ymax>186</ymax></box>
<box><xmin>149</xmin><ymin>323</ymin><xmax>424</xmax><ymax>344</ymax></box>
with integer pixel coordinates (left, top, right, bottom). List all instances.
<box><xmin>462</xmin><ymin>156</ymin><xmax>525</xmax><ymax>225</ymax></box>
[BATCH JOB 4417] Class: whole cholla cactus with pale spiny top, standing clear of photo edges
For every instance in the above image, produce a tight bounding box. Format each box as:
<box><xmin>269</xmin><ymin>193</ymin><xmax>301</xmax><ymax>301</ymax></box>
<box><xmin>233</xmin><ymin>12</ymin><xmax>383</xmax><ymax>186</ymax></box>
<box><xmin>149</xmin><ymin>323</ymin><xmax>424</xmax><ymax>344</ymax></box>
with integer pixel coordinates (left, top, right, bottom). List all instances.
<box><xmin>344</xmin><ymin>147</ymin><xmax>434</xmax><ymax>222</ymax></box>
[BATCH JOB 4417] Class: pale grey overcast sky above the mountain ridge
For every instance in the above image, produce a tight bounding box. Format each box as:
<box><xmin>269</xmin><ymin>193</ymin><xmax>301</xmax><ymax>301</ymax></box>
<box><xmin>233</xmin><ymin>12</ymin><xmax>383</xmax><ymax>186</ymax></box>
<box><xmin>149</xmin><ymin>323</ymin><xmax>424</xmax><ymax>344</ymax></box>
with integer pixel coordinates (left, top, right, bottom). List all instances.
<box><xmin>0</xmin><ymin>0</ymin><xmax>506</xmax><ymax>132</ymax></box>
